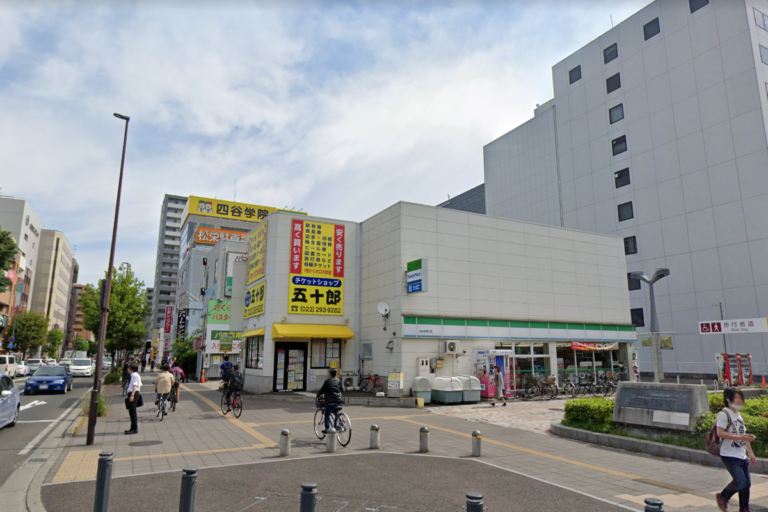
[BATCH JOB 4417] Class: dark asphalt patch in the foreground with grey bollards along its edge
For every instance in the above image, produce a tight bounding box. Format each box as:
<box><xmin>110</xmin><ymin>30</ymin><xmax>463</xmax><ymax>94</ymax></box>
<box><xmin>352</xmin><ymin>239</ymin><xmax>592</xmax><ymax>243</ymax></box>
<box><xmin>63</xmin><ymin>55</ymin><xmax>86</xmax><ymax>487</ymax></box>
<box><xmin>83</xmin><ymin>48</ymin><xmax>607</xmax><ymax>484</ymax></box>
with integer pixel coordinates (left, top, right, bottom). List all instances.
<box><xmin>42</xmin><ymin>450</ymin><xmax>626</xmax><ymax>512</ymax></box>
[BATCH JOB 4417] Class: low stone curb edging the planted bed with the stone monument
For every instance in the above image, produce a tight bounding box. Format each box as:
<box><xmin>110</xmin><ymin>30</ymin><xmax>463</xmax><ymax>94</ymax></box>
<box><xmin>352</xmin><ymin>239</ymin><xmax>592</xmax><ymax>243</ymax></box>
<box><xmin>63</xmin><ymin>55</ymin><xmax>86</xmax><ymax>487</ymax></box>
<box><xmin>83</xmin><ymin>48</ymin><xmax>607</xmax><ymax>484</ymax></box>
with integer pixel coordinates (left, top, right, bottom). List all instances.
<box><xmin>549</xmin><ymin>422</ymin><xmax>768</xmax><ymax>474</ymax></box>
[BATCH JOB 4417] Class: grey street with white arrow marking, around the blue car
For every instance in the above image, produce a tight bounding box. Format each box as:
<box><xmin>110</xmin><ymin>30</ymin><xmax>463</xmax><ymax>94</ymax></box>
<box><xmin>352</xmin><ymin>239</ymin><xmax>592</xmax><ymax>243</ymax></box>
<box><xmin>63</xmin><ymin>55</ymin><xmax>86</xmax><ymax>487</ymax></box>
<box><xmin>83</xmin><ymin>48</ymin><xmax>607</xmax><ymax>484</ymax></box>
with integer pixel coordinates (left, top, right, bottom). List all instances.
<box><xmin>0</xmin><ymin>377</ymin><xmax>93</xmax><ymax>485</ymax></box>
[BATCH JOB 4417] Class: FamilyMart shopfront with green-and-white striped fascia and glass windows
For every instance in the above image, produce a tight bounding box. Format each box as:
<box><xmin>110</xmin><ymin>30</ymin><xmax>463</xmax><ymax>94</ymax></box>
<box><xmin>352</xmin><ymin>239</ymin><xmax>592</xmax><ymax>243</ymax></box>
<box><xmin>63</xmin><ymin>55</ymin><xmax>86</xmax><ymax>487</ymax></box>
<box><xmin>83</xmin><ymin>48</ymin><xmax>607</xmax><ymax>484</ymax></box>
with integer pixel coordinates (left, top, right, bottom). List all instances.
<box><xmin>403</xmin><ymin>316</ymin><xmax>636</xmax><ymax>391</ymax></box>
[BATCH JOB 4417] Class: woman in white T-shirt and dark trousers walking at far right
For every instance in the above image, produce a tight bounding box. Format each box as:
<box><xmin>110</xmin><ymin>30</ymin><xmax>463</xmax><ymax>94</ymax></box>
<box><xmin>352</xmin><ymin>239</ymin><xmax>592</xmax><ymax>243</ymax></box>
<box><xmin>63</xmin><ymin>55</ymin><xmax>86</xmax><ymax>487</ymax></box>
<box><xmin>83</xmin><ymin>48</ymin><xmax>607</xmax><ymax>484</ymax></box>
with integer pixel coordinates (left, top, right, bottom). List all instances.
<box><xmin>715</xmin><ymin>388</ymin><xmax>757</xmax><ymax>512</ymax></box>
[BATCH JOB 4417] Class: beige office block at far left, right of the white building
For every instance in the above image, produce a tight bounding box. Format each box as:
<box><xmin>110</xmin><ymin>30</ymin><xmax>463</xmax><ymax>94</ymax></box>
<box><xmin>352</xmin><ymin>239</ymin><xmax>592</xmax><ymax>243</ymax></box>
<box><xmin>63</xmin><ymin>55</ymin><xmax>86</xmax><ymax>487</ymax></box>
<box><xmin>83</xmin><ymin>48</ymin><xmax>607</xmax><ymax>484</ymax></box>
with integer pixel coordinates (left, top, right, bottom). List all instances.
<box><xmin>30</xmin><ymin>229</ymin><xmax>74</xmax><ymax>334</ymax></box>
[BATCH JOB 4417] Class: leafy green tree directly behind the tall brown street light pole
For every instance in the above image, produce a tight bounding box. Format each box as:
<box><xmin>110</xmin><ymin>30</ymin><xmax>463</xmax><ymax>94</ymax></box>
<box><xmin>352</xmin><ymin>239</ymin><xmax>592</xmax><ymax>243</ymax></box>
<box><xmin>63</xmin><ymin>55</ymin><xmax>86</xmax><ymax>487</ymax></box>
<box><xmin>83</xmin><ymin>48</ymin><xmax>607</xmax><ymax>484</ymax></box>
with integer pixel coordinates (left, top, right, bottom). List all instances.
<box><xmin>80</xmin><ymin>263</ymin><xmax>150</xmax><ymax>361</ymax></box>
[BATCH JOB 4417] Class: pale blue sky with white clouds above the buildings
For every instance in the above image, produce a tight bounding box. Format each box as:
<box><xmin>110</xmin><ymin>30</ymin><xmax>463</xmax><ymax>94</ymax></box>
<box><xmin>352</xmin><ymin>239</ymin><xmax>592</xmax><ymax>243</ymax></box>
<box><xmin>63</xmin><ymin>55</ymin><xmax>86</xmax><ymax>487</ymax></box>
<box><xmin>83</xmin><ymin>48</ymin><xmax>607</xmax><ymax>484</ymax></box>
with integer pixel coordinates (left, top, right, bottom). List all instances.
<box><xmin>0</xmin><ymin>0</ymin><xmax>648</xmax><ymax>286</ymax></box>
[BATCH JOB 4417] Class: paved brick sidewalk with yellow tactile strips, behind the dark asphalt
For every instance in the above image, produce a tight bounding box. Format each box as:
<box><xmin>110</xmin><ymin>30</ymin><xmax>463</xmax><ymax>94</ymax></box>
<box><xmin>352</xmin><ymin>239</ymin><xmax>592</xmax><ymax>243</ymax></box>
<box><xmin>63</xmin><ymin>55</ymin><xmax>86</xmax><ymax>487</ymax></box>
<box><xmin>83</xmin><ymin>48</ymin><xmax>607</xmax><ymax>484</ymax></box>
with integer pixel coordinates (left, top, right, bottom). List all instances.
<box><xmin>46</xmin><ymin>384</ymin><xmax>768</xmax><ymax>512</ymax></box>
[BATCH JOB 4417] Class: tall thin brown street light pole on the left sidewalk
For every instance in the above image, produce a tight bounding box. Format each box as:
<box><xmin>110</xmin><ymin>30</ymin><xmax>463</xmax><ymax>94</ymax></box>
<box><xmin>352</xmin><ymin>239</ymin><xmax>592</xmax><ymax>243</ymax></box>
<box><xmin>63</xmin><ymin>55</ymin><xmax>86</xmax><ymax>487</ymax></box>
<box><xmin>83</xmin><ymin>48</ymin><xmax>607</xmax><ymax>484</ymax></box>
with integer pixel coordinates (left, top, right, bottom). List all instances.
<box><xmin>85</xmin><ymin>114</ymin><xmax>131</xmax><ymax>446</ymax></box>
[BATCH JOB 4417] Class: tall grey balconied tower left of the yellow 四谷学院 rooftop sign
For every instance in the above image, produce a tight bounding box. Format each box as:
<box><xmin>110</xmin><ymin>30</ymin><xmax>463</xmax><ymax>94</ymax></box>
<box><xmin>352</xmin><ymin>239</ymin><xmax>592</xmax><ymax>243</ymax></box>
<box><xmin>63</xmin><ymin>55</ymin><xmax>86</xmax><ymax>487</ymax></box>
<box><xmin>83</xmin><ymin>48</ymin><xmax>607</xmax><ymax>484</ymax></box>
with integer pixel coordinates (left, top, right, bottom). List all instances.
<box><xmin>150</xmin><ymin>194</ymin><xmax>187</xmax><ymax>340</ymax></box>
